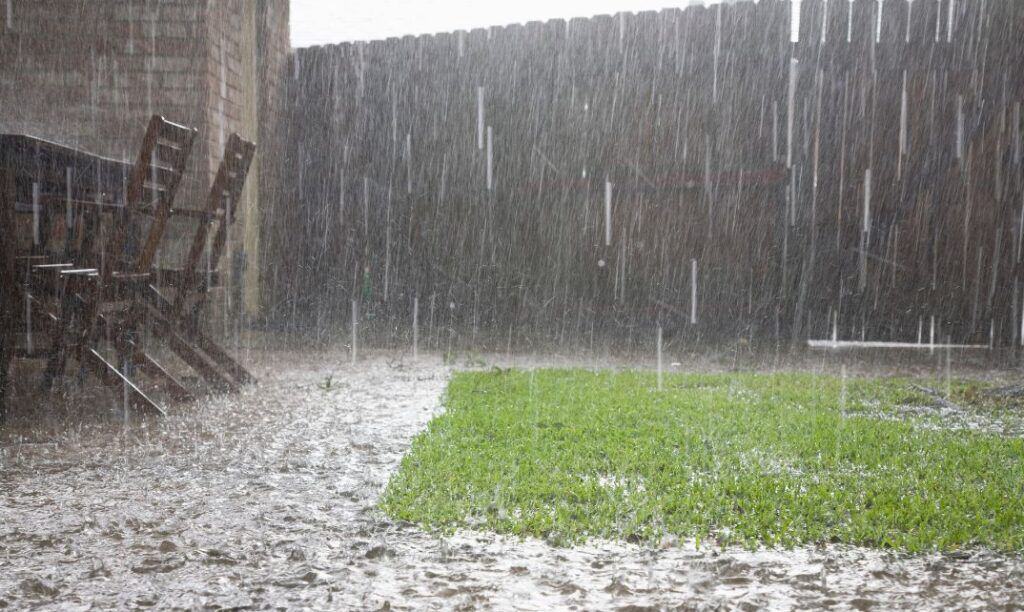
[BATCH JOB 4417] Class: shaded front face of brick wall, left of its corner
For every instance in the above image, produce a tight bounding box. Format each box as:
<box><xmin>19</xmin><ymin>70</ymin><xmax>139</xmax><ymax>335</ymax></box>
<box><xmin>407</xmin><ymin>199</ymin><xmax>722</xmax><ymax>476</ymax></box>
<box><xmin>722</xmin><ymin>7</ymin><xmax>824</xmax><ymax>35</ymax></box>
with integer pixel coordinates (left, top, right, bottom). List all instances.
<box><xmin>0</xmin><ymin>0</ymin><xmax>208</xmax><ymax>203</ymax></box>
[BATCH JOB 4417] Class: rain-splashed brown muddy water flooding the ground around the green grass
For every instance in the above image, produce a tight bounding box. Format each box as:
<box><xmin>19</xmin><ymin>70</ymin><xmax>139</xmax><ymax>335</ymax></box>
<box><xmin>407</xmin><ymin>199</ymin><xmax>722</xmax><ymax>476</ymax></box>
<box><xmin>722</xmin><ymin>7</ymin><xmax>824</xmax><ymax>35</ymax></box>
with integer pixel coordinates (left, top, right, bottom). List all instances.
<box><xmin>0</xmin><ymin>351</ymin><xmax>1024</xmax><ymax>610</ymax></box>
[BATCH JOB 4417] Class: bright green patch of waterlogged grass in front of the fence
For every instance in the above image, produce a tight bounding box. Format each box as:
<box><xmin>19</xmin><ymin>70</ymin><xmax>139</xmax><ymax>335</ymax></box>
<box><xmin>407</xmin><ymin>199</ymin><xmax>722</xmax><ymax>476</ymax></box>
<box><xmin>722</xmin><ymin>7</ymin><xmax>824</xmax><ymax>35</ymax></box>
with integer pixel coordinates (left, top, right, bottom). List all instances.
<box><xmin>383</xmin><ymin>369</ymin><xmax>1024</xmax><ymax>552</ymax></box>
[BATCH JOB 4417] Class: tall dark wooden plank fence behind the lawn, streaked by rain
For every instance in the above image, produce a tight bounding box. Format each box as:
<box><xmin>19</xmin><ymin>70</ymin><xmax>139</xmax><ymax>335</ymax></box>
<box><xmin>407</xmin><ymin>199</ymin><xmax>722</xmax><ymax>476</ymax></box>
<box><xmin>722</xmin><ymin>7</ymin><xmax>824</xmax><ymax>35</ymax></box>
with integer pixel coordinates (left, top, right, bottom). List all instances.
<box><xmin>271</xmin><ymin>1</ymin><xmax>1021</xmax><ymax>360</ymax></box>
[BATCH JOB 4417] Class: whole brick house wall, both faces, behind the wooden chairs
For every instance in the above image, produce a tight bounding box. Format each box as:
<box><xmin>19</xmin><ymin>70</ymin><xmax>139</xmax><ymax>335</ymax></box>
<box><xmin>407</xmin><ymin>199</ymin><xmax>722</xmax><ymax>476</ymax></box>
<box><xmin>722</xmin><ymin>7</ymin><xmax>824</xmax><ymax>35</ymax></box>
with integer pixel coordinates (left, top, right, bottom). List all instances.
<box><xmin>0</xmin><ymin>0</ymin><xmax>290</xmax><ymax>317</ymax></box>
